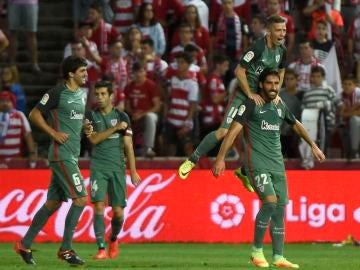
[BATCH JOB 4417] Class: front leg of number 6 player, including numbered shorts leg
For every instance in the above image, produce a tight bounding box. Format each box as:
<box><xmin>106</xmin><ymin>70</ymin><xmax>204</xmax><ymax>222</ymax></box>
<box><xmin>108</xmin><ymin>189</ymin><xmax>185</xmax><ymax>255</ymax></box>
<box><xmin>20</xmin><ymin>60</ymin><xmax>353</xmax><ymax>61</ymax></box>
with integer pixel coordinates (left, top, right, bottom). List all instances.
<box><xmin>51</xmin><ymin>160</ymin><xmax>87</xmax><ymax>265</ymax></box>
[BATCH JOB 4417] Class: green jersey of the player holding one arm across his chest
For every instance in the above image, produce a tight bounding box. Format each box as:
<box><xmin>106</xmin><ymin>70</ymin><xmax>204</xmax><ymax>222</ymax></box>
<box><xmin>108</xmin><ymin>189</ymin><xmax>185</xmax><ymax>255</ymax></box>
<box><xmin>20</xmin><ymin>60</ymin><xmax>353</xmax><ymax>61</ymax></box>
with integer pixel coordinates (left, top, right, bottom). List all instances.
<box><xmin>86</xmin><ymin>108</ymin><xmax>132</xmax><ymax>171</ymax></box>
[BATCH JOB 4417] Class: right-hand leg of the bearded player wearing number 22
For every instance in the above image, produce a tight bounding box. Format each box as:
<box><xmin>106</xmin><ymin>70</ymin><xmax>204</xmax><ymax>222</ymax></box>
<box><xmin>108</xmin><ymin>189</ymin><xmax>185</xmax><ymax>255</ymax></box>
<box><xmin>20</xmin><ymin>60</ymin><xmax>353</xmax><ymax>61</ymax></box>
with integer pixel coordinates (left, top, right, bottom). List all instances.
<box><xmin>270</xmin><ymin>172</ymin><xmax>299</xmax><ymax>268</ymax></box>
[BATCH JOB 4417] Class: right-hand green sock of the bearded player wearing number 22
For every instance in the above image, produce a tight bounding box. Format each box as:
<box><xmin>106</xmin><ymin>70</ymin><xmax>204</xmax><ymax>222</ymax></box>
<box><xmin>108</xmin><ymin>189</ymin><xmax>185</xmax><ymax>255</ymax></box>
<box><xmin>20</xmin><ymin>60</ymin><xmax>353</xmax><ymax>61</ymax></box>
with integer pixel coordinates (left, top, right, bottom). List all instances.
<box><xmin>270</xmin><ymin>205</ymin><xmax>285</xmax><ymax>257</ymax></box>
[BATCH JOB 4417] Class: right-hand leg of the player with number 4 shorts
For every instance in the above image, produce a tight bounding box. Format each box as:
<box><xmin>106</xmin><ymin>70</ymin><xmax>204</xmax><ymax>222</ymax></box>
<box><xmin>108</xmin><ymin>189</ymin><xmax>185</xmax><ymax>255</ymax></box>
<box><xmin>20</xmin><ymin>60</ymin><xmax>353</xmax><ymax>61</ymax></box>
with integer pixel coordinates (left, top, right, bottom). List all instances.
<box><xmin>108</xmin><ymin>171</ymin><xmax>127</xmax><ymax>259</ymax></box>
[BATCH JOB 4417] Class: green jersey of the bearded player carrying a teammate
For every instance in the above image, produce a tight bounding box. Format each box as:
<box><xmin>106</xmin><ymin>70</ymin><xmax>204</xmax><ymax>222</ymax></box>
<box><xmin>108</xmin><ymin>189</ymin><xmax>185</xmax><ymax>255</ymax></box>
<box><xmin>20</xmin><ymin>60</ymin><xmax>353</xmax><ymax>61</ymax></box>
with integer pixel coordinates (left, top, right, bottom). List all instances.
<box><xmin>234</xmin><ymin>99</ymin><xmax>296</xmax><ymax>171</ymax></box>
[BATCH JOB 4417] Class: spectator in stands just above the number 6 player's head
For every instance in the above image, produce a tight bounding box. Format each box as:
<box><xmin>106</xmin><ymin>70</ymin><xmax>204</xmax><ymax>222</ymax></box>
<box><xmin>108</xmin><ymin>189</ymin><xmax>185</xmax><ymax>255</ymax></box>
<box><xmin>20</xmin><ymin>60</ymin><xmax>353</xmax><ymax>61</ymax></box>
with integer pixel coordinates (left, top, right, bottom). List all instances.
<box><xmin>64</xmin><ymin>21</ymin><xmax>101</xmax><ymax>64</ymax></box>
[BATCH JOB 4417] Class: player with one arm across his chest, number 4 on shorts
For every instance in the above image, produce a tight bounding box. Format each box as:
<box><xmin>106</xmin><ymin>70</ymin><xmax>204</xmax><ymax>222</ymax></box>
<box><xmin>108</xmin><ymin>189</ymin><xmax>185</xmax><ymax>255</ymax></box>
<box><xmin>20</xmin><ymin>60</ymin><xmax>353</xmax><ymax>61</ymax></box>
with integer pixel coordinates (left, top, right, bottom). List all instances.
<box><xmin>87</xmin><ymin>81</ymin><xmax>140</xmax><ymax>260</ymax></box>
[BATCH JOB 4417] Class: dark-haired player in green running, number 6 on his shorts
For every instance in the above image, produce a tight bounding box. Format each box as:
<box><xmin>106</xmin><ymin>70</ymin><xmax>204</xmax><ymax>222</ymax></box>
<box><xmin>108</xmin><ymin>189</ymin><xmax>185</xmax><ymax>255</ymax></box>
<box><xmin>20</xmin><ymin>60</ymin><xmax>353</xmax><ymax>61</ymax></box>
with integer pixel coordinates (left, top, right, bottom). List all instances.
<box><xmin>15</xmin><ymin>56</ymin><xmax>92</xmax><ymax>265</ymax></box>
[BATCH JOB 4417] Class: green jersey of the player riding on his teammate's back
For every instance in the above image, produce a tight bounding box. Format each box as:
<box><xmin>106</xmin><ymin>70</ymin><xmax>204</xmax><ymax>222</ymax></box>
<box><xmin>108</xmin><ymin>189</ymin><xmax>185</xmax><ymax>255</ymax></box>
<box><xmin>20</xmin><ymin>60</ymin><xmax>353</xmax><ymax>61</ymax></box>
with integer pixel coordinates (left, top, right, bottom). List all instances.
<box><xmin>238</xmin><ymin>37</ymin><xmax>286</xmax><ymax>96</ymax></box>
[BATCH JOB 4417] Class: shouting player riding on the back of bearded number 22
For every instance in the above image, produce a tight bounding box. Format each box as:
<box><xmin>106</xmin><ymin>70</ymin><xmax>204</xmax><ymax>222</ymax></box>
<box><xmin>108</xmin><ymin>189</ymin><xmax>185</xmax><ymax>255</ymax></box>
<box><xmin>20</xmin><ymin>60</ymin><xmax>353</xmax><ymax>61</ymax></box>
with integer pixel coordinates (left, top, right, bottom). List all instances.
<box><xmin>178</xmin><ymin>15</ymin><xmax>286</xmax><ymax>192</ymax></box>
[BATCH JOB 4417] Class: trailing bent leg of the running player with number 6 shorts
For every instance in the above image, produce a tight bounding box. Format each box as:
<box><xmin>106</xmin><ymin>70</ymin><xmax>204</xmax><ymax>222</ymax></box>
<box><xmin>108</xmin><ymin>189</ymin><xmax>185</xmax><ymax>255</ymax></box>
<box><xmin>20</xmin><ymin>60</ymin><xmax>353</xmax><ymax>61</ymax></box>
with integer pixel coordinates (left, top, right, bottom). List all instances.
<box><xmin>14</xmin><ymin>170</ymin><xmax>63</xmax><ymax>264</ymax></box>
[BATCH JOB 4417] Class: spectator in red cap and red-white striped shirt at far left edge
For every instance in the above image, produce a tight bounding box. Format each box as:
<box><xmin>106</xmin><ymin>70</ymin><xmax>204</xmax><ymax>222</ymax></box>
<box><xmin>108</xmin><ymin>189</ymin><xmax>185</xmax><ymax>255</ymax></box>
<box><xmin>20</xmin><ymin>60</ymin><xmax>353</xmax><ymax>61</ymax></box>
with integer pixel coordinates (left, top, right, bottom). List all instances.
<box><xmin>0</xmin><ymin>91</ymin><xmax>36</xmax><ymax>164</ymax></box>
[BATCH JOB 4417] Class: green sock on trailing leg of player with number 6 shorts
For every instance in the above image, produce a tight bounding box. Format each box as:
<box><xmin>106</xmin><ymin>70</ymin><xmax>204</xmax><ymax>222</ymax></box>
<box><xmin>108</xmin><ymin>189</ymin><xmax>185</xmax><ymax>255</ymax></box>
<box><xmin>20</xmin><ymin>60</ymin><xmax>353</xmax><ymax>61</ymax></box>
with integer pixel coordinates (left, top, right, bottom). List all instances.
<box><xmin>21</xmin><ymin>204</ymin><xmax>56</xmax><ymax>248</ymax></box>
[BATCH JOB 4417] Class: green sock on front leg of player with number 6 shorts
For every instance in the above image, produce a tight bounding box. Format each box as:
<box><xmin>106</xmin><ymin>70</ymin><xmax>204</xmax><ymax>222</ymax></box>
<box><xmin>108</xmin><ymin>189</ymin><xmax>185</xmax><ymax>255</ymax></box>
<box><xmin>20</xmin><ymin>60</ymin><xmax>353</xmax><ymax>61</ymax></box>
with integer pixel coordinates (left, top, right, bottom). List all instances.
<box><xmin>61</xmin><ymin>204</ymin><xmax>84</xmax><ymax>250</ymax></box>
